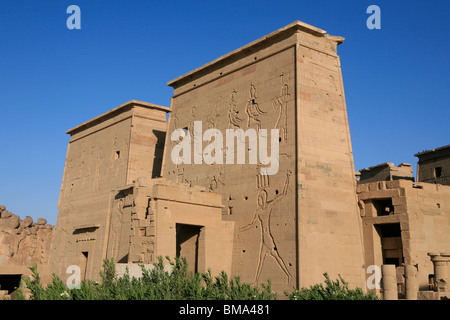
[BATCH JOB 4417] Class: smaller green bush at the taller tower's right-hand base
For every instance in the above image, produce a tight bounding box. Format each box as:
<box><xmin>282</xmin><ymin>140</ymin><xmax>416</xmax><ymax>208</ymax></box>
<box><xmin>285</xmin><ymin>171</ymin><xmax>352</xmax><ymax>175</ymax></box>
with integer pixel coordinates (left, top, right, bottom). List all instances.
<box><xmin>284</xmin><ymin>273</ymin><xmax>378</xmax><ymax>300</ymax></box>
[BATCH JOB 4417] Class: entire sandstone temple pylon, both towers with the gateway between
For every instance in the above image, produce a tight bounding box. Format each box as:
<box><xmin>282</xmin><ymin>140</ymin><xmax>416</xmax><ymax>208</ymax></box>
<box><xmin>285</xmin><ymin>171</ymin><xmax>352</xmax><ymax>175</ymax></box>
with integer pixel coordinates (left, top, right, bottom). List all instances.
<box><xmin>47</xmin><ymin>21</ymin><xmax>365</xmax><ymax>292</ymax></box>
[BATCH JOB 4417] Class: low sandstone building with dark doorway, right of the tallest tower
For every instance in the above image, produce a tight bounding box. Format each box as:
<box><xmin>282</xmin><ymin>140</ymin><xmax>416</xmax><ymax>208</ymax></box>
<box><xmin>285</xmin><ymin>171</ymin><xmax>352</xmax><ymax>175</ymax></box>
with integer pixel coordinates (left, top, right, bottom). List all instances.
<box><xmin>357</xmin><ymin>180</ymin><xmax>450</xmax><ymax>290</ymax></box>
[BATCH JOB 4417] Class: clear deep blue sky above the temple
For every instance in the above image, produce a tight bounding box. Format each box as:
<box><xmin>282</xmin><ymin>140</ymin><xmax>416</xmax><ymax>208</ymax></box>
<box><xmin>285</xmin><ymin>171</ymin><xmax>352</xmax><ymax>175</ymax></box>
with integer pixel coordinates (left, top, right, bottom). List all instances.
<box><xmin>0</xmin><ymin>0</ymin><xmax>450</xmax><ymax>224</ymax></box>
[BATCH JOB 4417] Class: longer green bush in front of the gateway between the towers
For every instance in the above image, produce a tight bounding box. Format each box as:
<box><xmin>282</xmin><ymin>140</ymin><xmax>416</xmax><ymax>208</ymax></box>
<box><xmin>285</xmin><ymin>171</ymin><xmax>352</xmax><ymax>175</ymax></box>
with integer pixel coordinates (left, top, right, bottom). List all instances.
<box><xmin>17</xmin><ymin>257</ymin><xmax>277</xmax><ymax>300</ymax></box>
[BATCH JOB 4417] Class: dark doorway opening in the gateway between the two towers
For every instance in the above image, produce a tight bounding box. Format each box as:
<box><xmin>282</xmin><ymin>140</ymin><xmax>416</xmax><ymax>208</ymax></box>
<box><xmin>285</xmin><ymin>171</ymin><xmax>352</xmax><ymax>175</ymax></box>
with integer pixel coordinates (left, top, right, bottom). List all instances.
<box><xmin>176</xmin><ymin>223</ymin><xmax>204</xmax><ymax>273</ymax></box>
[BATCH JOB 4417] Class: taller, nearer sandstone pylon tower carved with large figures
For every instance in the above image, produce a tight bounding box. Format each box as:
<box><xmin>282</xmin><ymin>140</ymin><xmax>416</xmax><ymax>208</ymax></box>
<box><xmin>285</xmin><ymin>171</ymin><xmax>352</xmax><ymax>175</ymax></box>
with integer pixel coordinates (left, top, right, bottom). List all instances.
<box><xmin>162</xmin><ymin>21</ymin><xmax>365</xmax><ymax>290</ymax></box>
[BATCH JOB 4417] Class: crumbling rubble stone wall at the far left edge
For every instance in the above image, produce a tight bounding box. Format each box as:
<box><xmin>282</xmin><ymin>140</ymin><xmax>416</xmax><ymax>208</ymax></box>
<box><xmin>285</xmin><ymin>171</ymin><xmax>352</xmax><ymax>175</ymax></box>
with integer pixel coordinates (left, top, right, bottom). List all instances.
<box><xmin>0</xmin><ymin>206</ymin><xmax>54</xmax><ymax>266</ymax></box>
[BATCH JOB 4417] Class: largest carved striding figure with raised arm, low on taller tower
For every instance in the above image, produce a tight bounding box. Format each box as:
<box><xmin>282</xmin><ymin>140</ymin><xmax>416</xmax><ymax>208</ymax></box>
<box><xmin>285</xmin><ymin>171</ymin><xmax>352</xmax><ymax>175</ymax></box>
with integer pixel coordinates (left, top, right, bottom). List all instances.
<box><xmin>240</xmin><ymin>170</ymin><xmax>292</xmax><ymax>284</ymax></box>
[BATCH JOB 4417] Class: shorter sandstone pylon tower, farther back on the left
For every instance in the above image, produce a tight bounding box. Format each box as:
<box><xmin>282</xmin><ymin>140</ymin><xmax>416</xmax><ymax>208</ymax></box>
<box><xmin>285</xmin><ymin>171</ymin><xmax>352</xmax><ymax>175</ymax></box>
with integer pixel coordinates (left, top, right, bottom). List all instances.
<box><xmin>50</xmin><ymin>100</ymin><xmax>168</xmax><ymax>280</ymax></box>
